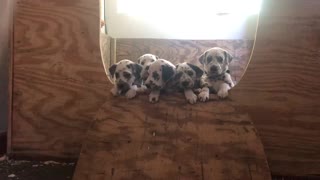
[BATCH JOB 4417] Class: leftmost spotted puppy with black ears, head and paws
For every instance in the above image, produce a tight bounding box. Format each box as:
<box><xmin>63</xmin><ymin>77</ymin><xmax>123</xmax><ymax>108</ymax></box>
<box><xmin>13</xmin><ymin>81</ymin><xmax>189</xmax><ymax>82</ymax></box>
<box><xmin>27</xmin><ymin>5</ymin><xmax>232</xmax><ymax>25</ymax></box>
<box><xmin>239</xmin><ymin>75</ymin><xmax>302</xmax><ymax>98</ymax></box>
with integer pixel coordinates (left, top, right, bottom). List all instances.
<box><xmin>109</xmin><ymin>59</ymin><xmax>142</xmax><ymax>99</ymax></box>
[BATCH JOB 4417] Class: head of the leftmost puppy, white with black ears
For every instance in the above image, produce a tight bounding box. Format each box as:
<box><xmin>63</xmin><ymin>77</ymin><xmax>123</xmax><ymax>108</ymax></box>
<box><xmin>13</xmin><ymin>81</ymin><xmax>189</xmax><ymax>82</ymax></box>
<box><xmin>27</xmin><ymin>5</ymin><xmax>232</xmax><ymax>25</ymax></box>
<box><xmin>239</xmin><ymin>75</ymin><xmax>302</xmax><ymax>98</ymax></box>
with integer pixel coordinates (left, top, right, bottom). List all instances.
<box><xmin>109</xmin><ymin>59</ymin><xmax>142</xmax><ymax>93</ymax></box>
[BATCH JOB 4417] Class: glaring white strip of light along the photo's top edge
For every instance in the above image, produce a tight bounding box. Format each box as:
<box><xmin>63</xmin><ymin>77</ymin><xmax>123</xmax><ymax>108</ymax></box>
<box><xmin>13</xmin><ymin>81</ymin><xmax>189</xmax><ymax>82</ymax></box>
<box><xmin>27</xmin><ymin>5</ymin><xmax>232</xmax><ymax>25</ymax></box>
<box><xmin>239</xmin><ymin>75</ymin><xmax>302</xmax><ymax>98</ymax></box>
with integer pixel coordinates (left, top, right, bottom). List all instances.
<box><xmin>117</xmin><ymin>0</ymin><xmax>262</xmax><ymax>17</ymax></box>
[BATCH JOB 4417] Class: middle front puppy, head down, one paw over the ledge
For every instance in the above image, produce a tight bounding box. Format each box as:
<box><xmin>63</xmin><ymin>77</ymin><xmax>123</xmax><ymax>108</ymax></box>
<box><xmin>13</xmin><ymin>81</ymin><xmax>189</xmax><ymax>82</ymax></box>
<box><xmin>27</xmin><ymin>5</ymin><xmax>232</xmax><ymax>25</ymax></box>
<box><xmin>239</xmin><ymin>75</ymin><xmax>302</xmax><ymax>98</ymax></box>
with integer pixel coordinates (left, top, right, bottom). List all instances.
<box><xmin>145</xmin><ymin>59</ymin><xmax>176</xmax><ymax>103</ymax></box>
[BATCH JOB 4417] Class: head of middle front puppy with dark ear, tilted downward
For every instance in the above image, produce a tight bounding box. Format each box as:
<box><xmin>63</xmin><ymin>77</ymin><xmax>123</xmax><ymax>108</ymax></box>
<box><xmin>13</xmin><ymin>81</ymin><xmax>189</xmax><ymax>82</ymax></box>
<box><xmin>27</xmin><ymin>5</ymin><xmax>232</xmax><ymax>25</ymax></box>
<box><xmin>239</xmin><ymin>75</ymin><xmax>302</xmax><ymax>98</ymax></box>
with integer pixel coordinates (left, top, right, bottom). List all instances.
<box><xmin>145</xmin><ymin>59</ymin><xmax>175</xmax><ymax>90</ymax></box>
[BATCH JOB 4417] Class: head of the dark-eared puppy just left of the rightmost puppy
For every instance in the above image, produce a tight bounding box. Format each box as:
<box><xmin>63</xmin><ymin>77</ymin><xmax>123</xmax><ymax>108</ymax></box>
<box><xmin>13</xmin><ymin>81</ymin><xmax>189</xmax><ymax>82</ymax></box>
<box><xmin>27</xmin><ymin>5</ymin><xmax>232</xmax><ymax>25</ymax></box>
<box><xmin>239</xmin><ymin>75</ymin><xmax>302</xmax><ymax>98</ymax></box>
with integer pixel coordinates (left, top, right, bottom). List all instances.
<box><xmin>174</xmin><ymin>62</ymin><xmax>203</xmax><ymax>89</ymax></box>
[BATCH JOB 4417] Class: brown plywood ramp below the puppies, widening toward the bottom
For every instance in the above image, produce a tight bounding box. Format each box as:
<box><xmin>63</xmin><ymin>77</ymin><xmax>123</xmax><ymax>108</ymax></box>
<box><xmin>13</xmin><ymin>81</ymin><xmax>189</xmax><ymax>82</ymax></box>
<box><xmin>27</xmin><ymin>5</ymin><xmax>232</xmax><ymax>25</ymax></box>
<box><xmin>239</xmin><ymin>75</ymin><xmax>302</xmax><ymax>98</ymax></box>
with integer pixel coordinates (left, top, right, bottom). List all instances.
<box><xmin>73</xmin><ymin>94</ymin><xmax>271</xmax><ymax>180</ymax></box>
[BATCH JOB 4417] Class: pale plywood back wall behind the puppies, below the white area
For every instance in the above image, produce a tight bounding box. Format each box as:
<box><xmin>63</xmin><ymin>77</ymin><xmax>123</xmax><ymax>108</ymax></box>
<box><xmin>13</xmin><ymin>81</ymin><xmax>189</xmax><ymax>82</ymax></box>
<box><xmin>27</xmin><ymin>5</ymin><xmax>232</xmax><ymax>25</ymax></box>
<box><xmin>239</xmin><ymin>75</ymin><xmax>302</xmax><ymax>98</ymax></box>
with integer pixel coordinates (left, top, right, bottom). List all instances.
<box><xmin>117</xmin><ymin>39</ymin><xmax>253</xmax><ymax>82</ymax></box>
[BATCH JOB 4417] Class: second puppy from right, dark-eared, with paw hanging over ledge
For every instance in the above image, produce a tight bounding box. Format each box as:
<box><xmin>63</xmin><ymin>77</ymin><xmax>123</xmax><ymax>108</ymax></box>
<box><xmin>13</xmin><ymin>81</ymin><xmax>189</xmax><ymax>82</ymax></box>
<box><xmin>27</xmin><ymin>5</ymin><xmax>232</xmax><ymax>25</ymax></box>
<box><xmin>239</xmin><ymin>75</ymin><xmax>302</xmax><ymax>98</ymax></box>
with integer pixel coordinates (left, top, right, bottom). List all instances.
<box><xmin>174</xmin><ymin>62</ymin><xmax>203</xmax><ymax>104</ymax></box>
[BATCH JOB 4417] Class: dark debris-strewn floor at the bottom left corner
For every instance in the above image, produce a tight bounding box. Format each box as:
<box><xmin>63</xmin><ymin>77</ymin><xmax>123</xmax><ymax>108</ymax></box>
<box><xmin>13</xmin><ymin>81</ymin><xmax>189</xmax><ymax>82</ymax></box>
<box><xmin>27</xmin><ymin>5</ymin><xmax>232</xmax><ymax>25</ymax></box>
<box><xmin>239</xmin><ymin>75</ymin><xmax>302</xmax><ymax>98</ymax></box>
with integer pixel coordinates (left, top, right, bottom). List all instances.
<box><xmin>0</xmin><ymin>156</ymin><xmax>75</xmax><ymax>180</ymax></box>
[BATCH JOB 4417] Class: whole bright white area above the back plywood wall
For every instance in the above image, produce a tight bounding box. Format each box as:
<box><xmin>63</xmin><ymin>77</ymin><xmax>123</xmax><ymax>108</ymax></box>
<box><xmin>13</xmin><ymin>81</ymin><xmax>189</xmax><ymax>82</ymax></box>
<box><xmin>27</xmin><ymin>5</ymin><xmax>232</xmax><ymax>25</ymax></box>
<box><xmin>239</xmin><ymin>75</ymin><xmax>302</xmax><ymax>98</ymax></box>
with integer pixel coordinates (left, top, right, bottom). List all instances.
<box><xmin>107</xmin><ymin>0</ymin><xmax>262</xmax><ymax>39</ymax></box>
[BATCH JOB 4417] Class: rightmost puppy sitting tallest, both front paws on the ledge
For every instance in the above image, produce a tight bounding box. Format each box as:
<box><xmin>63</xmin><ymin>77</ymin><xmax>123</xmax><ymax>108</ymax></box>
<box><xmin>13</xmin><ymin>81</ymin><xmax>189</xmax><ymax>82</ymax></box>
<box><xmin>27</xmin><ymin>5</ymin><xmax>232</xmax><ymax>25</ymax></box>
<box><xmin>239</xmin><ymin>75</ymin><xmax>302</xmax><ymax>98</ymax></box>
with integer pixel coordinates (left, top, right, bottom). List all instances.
<box><xmin>198</xmin><ymin>47</ymin><xmax>234</xmax><ymax>102</ymax></box>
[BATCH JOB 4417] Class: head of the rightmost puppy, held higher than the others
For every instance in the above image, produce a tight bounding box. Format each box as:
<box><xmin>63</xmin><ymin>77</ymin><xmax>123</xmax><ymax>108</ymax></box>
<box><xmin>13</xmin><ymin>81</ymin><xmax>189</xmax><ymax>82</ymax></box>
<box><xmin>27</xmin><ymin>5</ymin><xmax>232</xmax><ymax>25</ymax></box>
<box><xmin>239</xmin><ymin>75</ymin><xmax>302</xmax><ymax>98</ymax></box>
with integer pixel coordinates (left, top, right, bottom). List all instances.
<box><xmin>199</xmin><ymin>47</ymin><xmax>233</xmax><ymax>76</ymax></box>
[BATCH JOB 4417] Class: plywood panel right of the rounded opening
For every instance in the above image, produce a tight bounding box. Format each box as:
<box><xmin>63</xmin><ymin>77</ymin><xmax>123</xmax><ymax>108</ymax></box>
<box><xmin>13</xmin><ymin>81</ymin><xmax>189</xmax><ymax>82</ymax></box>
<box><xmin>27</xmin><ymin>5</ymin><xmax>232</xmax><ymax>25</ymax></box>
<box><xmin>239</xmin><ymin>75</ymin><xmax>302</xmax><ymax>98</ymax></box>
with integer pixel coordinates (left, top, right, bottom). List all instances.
<box><xmin>231</xmin><ymin>0</ymin><xmax>320</xmax><ymax>176</ymax></box>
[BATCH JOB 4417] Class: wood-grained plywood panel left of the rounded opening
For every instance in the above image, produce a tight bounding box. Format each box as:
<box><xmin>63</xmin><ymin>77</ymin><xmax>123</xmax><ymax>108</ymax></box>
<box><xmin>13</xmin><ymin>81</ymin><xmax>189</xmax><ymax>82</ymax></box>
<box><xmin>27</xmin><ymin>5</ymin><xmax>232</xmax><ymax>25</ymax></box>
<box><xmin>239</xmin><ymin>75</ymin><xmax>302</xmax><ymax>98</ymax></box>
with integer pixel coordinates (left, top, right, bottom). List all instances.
<box><xmin>10</xmin><ymin>0</ymin><xmax>108</xmax><ymax>158</ymax></box>
